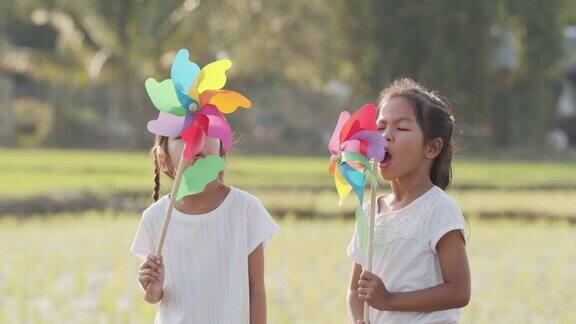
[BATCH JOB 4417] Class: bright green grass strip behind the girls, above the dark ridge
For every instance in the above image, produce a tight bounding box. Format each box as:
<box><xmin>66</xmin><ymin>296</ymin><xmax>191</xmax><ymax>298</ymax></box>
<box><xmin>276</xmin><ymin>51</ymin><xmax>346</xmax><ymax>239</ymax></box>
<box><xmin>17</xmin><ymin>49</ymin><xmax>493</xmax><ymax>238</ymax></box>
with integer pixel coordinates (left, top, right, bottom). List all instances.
<box><xmin>0</xmin><ymin>149</ymin><xmax>576</xmax><ymax>198</ymax></box>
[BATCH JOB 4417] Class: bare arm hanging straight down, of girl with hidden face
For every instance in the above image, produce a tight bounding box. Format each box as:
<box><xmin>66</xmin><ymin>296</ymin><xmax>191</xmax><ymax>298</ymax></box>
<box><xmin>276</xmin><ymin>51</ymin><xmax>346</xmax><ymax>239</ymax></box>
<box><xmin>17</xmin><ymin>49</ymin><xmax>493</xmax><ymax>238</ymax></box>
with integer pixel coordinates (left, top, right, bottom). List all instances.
<box><xmin>248</xmin><ymin>244</ymin><xmax>266</xmax><ymax>324</ymax></box>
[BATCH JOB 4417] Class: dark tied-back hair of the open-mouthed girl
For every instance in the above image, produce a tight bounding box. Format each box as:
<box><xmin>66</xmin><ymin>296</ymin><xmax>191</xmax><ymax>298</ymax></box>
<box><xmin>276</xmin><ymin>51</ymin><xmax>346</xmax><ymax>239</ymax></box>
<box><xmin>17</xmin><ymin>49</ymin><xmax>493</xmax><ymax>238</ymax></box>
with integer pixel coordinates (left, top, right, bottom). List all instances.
<box><xmin>378</xmin><ymin>78</ymin><xmax>455</xmax><ymax>189</ymax></box>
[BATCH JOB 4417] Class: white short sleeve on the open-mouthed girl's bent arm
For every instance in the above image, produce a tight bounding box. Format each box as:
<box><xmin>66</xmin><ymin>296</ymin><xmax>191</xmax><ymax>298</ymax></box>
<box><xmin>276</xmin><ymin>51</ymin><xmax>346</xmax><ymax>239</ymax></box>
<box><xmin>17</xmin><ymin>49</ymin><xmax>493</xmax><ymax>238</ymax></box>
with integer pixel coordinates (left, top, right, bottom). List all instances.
<box><xmin>429</xmin><ymin>196</ymin><xmax>466</xmax><ymax>253</ymax></box>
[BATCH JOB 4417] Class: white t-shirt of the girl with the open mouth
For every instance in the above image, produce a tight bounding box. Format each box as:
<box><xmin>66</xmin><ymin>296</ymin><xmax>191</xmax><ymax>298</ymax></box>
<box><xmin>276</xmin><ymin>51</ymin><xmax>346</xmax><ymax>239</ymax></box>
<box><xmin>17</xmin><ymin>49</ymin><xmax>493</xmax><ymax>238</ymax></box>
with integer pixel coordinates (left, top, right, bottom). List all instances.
<box><xmin>347</xmin><ymin>186</ymin><xmax>466</xmax><ymax>324</ymax></box>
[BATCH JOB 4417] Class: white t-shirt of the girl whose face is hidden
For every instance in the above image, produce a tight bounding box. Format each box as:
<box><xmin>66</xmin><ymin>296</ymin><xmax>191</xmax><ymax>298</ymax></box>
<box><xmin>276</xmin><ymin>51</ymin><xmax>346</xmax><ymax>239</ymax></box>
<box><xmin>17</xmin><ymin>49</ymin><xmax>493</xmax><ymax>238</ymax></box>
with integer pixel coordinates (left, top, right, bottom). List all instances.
<box><xmin>130</xmin><ymin>188</ymin><xmax>279</xmax><ymax>324</ymax></box>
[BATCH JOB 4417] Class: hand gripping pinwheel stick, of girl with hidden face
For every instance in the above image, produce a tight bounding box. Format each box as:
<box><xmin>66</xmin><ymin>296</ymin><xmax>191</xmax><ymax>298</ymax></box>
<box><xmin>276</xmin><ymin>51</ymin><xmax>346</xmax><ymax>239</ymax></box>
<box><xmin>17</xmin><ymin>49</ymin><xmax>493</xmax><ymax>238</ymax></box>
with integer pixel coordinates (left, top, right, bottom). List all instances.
<box><xmin>138</xmin><ymin>254</ymin><xmax>164</xmax><ymax>303</ymax></box>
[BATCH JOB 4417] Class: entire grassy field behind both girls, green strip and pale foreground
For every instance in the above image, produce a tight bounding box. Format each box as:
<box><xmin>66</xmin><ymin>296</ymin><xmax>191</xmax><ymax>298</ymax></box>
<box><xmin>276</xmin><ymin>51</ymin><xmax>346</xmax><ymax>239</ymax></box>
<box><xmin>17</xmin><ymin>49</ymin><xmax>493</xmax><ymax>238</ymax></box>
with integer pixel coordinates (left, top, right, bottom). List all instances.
<box><xmin>0</xmin><ymin>150</ymin><xmax>576</xmax><ymax>323</ymax></box>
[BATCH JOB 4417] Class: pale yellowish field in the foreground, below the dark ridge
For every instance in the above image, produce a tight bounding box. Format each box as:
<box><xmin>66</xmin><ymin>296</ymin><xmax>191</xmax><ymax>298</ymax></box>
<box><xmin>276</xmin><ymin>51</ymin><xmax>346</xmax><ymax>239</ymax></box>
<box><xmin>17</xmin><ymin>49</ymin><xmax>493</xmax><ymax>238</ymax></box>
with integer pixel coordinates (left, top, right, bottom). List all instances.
<box><xmin>0</xmin><ymin>212</ymin><xmax>576</xmax><ymax>324</ymax></box>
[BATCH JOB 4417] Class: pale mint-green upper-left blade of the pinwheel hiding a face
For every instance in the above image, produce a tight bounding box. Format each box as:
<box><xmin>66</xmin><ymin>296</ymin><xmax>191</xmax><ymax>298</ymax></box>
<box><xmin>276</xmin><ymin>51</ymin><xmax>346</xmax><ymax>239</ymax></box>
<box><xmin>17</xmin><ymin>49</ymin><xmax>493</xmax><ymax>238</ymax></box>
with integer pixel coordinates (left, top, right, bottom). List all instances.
<box><xmin>144</xmin><ymin>78</ymin><xmax>186</xmax><ymax>117</ymax></box>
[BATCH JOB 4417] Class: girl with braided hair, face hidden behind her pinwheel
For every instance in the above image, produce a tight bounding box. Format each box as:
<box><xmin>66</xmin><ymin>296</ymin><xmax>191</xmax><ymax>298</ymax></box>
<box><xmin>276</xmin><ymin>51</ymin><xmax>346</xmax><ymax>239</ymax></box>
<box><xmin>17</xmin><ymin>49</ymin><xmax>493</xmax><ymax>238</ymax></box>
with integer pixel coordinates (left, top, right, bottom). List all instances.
<box><xmin>131</xmin><ymin>135</ymin><xmax>279</xmax><ymax>324</ymax></box>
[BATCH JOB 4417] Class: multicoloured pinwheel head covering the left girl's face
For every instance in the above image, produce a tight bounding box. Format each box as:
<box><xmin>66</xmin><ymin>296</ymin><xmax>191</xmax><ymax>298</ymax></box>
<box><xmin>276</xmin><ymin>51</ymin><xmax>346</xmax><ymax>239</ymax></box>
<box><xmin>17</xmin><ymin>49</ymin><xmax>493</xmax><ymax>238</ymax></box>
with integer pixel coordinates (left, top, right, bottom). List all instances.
<box><xmin>145</xmin><ymin>49</ymin><xmax>252</xmax><ymax>159</ymax></box>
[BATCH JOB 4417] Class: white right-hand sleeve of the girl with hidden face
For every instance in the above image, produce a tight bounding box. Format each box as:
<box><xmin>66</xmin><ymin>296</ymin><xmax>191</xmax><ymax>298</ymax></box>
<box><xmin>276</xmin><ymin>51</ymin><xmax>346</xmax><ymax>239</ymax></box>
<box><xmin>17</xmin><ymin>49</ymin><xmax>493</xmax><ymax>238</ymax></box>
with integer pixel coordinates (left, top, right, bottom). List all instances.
<box><xmin>247</xmin><ymin>199</ymin><xmax>280</xmax><ymax>254</ymax></box>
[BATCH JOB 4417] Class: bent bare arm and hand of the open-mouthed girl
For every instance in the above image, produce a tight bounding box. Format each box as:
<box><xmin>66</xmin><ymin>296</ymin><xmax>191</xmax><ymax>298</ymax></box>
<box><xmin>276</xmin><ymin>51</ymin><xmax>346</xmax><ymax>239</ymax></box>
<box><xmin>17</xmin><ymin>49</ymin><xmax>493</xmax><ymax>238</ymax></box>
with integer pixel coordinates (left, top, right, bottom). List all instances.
<box><xmin>358</xmin><ymin>230</ymin><xmax>471</xmax><ymax>312</ymax></box>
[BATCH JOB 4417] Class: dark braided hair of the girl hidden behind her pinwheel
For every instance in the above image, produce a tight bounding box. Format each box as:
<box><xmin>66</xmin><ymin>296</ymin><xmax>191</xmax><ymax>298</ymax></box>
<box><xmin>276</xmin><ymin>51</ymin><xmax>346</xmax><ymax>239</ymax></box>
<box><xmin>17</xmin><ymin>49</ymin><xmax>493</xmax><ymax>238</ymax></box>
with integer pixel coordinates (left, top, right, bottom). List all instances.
<box><xmin>150</xmin><ymin>135</ymin><xmax>226</xmax><ymax>202</ymax></box>
